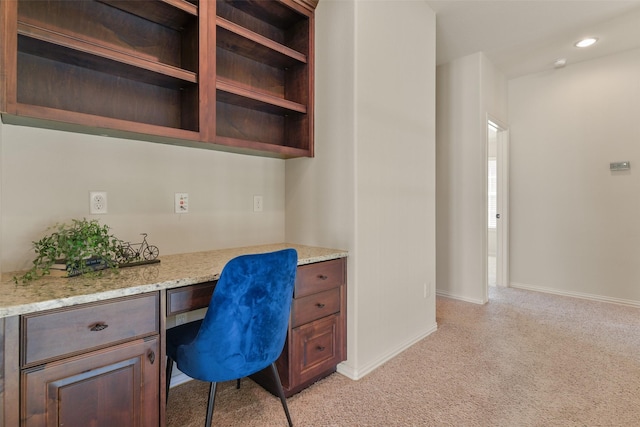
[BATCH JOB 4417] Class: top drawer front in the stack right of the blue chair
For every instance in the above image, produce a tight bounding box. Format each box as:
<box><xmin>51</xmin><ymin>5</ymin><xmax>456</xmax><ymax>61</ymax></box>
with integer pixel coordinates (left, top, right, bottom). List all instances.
<box><xmin>295</xmin><ymin>258</ymin><xmax>345</xmax><ymax>298</ymax></box>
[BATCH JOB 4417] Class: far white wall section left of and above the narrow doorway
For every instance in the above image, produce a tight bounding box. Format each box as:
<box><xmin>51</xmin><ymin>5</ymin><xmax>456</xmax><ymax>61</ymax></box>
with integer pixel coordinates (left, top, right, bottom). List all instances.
<box><xmin>436</xmin><ymin>53</ymin><xmax>507</xmax><ymax>303</ymax></box>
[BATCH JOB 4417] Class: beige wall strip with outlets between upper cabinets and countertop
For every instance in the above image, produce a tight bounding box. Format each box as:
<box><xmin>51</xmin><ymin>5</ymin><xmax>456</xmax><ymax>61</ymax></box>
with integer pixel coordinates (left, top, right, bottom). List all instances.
<box><xmin>0</xmin><ymin>124</ymin><xmax>285</xmax><ymax>272</ymax></box>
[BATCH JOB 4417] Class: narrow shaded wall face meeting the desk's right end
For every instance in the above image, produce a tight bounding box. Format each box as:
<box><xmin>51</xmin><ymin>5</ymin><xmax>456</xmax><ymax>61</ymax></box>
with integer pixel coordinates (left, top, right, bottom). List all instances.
<box><xmin>285</xmin><ymin>1</ymin><xmax>358</xmax><ymax>377</ymax></box>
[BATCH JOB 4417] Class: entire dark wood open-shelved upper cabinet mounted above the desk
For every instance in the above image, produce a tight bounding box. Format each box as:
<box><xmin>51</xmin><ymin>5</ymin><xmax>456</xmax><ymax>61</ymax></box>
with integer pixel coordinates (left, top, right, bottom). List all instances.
<box><xmin>0</xmin><ymin>0</ymin><xmax>316</xmax><ymax>158</ymax></box>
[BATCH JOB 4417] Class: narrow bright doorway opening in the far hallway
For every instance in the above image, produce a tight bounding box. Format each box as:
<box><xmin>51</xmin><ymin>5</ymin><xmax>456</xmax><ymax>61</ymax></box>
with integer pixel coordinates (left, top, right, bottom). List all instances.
<box><xmin>486</xmin><ymin>118</ymin><xmax>509</xmax><ymax>286</ymax></box>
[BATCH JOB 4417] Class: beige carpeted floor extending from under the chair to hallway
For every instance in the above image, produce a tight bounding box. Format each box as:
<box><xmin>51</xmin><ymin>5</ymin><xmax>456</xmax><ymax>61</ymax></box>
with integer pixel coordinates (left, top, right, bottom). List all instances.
<box><xmin>167</xmin><ymin>288</ymin><xmax>640</xmax><ymax>427</ymax></box>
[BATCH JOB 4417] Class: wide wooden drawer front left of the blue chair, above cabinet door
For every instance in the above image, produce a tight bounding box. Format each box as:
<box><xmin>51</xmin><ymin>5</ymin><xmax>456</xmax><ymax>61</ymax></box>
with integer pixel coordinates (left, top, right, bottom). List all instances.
<box><xmin>21</xmin><ymin>292</ymin><xmax>160</xmax><ymax>367</ymax></box>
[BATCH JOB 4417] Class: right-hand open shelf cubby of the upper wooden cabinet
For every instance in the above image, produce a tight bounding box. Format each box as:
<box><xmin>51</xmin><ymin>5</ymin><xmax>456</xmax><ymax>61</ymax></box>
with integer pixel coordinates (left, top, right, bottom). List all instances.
<box><xmin>216</xmin><ymin>1</ymin><xmax>313</xmax><ymax>156</ymax></box>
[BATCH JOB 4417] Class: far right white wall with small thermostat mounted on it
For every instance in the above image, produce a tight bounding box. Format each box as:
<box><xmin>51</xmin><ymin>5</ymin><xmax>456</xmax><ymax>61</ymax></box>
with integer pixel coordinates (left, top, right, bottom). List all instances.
<box><xmin>509</xmin><ymin>50</ymin><xmax>640</xmax><ymax>304</ymax></box>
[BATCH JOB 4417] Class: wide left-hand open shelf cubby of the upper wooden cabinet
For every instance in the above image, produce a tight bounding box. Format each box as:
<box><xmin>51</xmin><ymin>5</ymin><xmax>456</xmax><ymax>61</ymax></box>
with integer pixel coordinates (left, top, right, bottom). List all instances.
<box><xmin>16</xmin><ymin>0</ymin><xmax>199</xmax><ymax>131</ymax></box>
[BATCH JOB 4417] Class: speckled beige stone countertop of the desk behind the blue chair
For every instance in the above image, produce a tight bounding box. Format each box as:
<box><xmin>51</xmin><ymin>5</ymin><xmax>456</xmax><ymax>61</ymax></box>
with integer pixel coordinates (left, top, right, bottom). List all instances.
<box><xmin>0</xmin><ymin>243</ymin><xmax>347</xmax><ymax>318</ymax></box>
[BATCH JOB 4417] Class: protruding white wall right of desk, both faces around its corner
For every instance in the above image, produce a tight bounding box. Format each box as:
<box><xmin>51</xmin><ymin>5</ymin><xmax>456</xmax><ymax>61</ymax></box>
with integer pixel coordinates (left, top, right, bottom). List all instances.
<box><xmin>286</xmin><ymin>0</ymin><xmax>436</xmax><ymax>378</ymax></box>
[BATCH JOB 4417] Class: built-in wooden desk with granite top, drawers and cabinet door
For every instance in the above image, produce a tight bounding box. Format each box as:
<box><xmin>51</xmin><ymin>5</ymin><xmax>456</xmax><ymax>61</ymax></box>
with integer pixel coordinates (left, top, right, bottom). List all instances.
<box><xmin>0</xmin><ymin>244</ymin><xmax>347</xmax><ymax>427</ymax></box>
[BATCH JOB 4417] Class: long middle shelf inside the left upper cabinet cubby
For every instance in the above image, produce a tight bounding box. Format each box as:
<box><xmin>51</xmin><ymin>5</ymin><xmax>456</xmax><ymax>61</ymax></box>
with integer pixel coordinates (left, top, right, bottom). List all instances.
<box><xmin>18</xmin><ymin>22</ymin><xmax>198</xmax><ymax>89</ymax></box>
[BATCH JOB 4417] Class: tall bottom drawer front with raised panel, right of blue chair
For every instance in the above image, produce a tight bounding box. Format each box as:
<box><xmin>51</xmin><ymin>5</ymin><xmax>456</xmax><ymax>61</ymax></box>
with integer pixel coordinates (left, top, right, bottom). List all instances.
<box><xmin>291</xmin><ymin>314</ymin><xmax>343</xmax><ymax>384</ymax></box>
